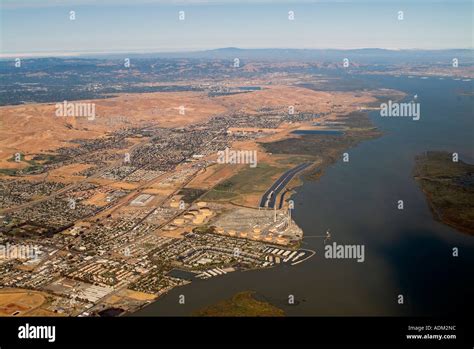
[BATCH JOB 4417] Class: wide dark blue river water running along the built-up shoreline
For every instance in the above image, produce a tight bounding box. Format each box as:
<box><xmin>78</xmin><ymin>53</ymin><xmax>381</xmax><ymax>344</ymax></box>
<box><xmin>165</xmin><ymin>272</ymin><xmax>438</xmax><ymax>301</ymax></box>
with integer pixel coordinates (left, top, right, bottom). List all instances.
<box><xmin>132</xmin><ymin>76</ymin><xmax>474</xmax><ymax>316</ymax></box>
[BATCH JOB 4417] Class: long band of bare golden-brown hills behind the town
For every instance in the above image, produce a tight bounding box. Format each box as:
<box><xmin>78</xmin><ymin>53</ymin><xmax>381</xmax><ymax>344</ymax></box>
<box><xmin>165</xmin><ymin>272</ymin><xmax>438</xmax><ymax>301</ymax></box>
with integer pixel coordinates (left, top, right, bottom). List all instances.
<box><xmin>0</xmin><ymin>86</ymin><xmax>373</xmax><ymax>168</ymax></box>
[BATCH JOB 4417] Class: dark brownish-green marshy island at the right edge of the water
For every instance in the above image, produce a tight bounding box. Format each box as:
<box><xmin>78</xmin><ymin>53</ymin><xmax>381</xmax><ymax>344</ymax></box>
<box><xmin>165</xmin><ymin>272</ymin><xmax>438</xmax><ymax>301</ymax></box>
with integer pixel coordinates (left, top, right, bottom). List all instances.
<box><xmin>414</xmin><ymin>151</ymin><xmax>474</xmax><ymax>235</ymax></box>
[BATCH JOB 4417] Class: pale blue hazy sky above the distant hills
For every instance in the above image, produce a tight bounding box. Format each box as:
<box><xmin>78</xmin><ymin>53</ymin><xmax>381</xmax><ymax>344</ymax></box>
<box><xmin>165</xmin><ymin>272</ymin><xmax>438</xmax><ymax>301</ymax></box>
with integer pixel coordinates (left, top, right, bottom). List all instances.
<box><xmin>0</xmin><ymin>0</ymin><xmax>473</xmax><ymax>57</ymax></box>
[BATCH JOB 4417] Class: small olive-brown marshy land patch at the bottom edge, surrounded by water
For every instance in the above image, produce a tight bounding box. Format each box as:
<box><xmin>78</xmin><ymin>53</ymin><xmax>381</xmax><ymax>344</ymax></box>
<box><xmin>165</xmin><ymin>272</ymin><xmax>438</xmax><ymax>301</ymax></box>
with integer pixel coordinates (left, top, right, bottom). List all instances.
<box><xmin>193</xmin><ymin>291</ymin><xmax>285</xmax><ymax>316</ymax></box>
